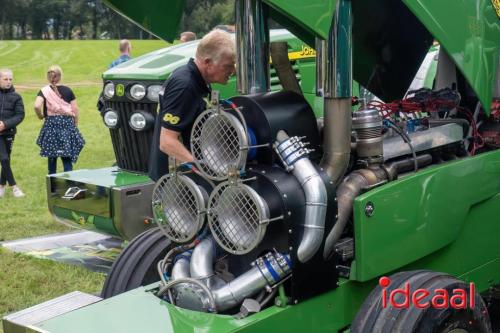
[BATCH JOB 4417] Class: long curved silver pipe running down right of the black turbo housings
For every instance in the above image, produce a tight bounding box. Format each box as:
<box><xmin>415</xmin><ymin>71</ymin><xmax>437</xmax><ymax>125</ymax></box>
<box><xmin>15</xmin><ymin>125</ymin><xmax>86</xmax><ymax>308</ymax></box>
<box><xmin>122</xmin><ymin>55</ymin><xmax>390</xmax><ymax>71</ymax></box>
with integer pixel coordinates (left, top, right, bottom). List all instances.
<box><xmin>275</xmin><ymin>131</ymin><xmax>328</xmax><ymax>263</ymax></box>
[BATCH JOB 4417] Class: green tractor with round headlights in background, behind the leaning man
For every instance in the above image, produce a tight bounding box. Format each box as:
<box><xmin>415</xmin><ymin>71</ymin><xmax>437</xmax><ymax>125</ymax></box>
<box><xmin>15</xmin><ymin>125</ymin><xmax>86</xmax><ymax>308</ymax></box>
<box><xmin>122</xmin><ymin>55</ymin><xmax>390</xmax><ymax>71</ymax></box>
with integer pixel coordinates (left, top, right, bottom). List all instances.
<box><xmin>47</xmin><ymin>29</ymin><xmax>323</xmax><ymax>240</ymax></box>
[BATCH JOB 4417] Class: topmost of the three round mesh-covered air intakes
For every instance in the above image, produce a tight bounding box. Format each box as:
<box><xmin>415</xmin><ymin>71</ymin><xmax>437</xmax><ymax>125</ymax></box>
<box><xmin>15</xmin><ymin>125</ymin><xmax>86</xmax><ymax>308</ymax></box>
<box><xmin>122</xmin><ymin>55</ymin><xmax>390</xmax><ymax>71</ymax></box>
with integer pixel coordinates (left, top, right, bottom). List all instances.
<box><xmin>191</xmin><ymin>110</ymin><xmax>248</xmax><ymax>181</ymax></box>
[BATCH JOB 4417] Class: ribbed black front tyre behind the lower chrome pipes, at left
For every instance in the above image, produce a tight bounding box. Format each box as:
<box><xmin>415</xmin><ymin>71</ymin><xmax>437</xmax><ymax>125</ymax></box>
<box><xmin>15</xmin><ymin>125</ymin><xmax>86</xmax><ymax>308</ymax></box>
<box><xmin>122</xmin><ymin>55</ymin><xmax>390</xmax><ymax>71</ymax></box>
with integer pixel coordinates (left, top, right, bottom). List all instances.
<box><xmin>101</xmin><ymin>228</ymin><xmax>171</xmax><ymax>298</ymax></box>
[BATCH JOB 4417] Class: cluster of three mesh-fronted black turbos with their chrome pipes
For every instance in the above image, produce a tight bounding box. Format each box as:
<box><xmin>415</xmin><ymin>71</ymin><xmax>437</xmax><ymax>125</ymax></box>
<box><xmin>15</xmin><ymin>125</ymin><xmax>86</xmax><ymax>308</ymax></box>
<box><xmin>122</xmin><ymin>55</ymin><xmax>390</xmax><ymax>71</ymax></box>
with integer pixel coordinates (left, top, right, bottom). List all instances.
<box><xmin>153</xmin><ymin>92</ymin><xmax>337</xmax><ymax>312</ymax></box>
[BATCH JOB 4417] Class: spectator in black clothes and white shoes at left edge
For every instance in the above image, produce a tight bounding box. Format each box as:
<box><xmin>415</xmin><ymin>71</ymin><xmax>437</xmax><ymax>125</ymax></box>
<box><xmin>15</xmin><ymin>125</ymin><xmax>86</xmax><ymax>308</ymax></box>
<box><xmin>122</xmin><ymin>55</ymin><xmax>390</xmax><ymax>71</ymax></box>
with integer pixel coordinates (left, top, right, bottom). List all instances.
<box><xmin>0</xmin><ymin>69</ymin><xmax>24</xmax><ymax>198</ymax></box>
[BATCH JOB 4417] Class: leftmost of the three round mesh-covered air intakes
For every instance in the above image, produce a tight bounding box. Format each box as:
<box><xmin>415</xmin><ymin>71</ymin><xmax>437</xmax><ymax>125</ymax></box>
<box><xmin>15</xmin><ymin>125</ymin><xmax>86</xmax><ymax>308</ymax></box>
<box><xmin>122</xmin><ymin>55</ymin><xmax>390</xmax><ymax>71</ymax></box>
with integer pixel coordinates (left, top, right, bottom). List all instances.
<box><xmin>153</xmin><ymin>173</ymin><xmax>208</xmax><ymax>243</ymax></box>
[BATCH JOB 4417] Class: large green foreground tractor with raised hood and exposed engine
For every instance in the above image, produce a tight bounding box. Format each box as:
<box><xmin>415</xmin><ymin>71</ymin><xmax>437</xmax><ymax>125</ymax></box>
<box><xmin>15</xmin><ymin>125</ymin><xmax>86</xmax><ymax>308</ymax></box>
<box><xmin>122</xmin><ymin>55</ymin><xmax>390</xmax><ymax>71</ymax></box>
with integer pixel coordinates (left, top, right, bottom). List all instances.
<box><xmin>4</xmin><ymin>0</ymin><xmax>500</xmax><ymax>333</ymax></box>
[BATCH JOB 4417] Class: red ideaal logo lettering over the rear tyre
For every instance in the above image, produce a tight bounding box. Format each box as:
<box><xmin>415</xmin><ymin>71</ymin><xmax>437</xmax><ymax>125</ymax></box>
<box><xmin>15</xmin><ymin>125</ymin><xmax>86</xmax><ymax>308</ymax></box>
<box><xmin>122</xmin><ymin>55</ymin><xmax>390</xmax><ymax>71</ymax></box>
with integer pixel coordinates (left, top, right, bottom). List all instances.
<box><xmin>378</xmin><ymin>276</ymin><xmax>475</xmax><ymax>309</ymax></box>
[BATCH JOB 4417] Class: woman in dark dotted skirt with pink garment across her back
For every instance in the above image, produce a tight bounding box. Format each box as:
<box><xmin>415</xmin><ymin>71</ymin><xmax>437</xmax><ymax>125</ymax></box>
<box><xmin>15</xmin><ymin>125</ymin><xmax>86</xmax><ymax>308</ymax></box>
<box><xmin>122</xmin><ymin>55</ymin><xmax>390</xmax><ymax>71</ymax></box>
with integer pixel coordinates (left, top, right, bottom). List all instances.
<box><xmin>35</xmin><ymin>65</ymin><xmax>85</xmax><ymax>175</ymax></box>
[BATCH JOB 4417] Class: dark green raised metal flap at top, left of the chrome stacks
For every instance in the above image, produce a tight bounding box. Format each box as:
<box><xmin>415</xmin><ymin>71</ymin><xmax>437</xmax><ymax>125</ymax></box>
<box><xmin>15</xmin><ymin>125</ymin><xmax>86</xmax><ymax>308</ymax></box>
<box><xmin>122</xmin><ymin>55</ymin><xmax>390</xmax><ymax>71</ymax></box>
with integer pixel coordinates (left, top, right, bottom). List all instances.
<box><xmin>104</xmin><ymin>0</ymin><xmax>185</xmax><ymax>41</ymax></box>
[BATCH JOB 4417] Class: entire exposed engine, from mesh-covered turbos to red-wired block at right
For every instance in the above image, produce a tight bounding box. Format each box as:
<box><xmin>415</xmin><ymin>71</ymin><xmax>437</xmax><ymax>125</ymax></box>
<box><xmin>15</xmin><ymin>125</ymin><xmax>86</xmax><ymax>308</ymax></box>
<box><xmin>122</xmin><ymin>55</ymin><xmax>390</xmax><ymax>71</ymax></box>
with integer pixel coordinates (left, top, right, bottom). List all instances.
<box><xmin>153</xmin><ymin>89</ymin><xmax>492</xmax><ymax>314</ymax></box>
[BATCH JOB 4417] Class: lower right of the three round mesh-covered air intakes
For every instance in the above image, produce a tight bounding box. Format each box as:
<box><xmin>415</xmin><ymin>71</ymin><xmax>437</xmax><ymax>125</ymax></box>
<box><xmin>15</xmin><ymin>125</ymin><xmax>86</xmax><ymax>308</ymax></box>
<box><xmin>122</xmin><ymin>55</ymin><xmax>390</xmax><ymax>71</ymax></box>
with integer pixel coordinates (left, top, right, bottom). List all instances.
<box><xmin>208</xmin><ymin>182</ymin><xmax>270</xmax><ymax>254</ymax></box>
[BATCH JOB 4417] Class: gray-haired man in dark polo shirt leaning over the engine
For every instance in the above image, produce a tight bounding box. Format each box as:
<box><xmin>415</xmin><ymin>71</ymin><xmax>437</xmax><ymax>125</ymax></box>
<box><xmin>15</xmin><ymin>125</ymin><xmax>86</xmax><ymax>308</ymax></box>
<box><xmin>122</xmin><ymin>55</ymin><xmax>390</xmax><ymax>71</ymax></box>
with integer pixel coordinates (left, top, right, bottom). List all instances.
<box><xmin>149</xmin><ymin>30</ymin><xmax>236</xmax><ymax>181</ymax></box>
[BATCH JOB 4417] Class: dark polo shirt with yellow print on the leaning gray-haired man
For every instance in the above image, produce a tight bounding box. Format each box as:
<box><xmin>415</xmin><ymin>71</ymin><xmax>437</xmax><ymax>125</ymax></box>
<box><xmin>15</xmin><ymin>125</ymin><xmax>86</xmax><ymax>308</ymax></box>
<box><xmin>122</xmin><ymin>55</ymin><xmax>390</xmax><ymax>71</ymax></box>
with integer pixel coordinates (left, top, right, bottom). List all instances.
<box><xmin>149</xmin><ymin>59</ymin><xmax>210</xmax><ymax>181</ymax></box>
